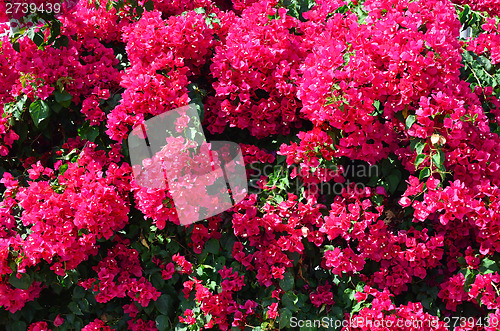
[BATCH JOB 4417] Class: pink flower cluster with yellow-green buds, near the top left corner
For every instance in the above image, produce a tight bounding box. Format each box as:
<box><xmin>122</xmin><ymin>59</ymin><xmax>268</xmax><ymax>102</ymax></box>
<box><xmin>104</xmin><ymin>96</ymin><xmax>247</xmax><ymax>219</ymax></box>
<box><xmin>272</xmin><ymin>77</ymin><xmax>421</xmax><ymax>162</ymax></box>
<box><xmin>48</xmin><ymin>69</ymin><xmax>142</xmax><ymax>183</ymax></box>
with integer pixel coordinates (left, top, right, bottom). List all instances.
<box><xmin>12</xmin><ymin>27</ymin><xmax>120</xmax><ymax>103</ymax></box>
